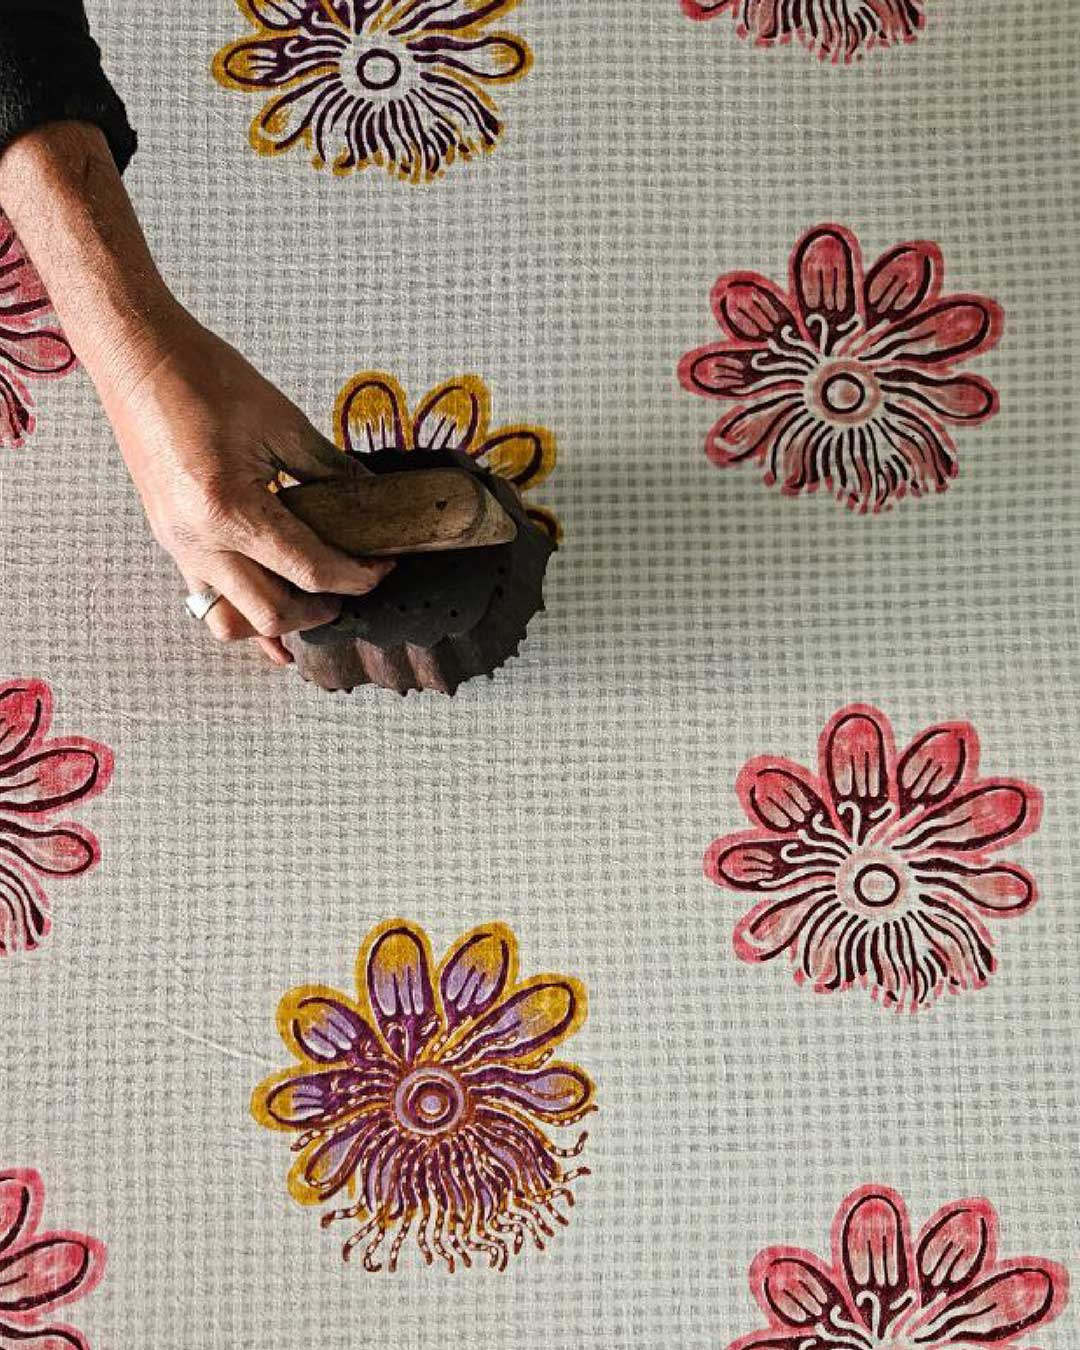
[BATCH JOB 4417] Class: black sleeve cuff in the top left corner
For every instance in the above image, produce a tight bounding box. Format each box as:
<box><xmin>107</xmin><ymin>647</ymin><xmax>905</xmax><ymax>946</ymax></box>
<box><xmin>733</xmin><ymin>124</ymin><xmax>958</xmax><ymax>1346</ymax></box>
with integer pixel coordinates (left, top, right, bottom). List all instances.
<box><xmin>0</xmin><ymin>0</ymin><xmax>135</xmax><ymax>170</ymax></box>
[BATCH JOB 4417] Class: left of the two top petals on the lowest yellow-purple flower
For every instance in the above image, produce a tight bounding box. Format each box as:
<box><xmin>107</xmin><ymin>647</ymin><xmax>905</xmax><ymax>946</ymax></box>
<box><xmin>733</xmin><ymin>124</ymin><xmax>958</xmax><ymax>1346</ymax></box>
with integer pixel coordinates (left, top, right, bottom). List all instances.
<box><xmin>358</xmin><ymin>922</ymin><xmax>439</xmax><ymax>1064</ymax></box>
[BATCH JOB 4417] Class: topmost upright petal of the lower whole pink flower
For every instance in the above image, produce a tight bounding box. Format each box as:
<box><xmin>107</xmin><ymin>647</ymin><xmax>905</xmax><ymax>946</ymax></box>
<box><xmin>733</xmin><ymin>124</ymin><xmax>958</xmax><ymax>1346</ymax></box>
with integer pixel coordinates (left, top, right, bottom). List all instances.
<box><xmin>819</xmin><ymin>703</ymin><xmax>896</xmax><ymax>844</ymax></box>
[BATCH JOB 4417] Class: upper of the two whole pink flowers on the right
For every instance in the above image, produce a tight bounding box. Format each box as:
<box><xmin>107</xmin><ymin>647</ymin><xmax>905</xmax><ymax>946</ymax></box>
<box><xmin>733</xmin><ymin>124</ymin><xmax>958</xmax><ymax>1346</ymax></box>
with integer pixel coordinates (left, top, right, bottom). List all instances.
<box><xmin>679</xmin><ymin>225</ymin><xmax>1003</xmax><ymax>512</ymax></box>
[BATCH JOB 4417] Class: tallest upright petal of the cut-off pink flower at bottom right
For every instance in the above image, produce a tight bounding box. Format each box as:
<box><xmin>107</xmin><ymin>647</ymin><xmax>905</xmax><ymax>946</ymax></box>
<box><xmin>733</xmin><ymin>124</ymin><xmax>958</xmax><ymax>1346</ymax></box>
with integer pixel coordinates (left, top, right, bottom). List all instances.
<box><xmin>833</xmin><ymin>1187</ymin><xmax>913</xmax><ymax>1335</ymax></box>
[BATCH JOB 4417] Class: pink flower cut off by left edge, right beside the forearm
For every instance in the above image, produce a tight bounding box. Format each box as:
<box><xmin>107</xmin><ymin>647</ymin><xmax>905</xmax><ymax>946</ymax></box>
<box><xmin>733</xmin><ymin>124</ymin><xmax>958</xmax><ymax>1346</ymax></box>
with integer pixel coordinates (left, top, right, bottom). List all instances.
<box><xmin>0</xmin><ymin>212</ymin><xmax>76</xmax><ymax>447</ymax></box>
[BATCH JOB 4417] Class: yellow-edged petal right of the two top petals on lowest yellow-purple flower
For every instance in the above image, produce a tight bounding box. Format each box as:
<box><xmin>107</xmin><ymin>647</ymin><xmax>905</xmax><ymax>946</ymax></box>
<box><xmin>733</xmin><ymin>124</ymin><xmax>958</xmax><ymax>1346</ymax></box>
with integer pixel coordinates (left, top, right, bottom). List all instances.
<box><xmin>441</xmin><ymin>975</ymin><xmax>586</xmax><ymax>1064</ymax></box>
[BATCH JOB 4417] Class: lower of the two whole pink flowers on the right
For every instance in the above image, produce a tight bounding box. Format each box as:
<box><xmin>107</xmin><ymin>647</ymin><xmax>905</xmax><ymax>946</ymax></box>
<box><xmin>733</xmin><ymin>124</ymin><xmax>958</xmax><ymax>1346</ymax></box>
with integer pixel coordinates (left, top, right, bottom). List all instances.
<box><xmin>705</xmin><ymin>703</ymin><xmax>1042</xmax><ymax>1013</ymax></box>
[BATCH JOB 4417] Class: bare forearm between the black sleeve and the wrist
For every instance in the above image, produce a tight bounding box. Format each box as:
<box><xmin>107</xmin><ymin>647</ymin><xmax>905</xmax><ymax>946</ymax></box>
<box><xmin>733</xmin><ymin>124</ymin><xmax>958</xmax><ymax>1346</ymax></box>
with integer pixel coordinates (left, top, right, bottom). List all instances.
<box><xmin>0</xmin><ymin>122</ymin><xmax>186</xmax><ymax>397</ymax></box>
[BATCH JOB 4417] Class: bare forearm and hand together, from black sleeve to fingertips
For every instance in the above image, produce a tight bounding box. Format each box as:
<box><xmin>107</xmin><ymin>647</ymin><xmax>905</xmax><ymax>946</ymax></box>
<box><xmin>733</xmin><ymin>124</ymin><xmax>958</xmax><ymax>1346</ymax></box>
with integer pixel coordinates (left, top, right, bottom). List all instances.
<box><xmin>0</xmin><ymin>122</ymin><xmax>393</xmax><ymax>664</ymax></box>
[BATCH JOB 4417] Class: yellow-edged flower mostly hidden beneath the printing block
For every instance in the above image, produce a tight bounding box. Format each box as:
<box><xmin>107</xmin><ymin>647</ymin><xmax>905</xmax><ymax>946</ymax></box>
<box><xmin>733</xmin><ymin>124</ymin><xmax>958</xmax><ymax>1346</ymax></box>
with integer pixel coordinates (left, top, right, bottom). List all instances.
<box><xmin>333</xmin><ymin>370</ymin><xmax>562</xmax><ymax>543</ymax></box>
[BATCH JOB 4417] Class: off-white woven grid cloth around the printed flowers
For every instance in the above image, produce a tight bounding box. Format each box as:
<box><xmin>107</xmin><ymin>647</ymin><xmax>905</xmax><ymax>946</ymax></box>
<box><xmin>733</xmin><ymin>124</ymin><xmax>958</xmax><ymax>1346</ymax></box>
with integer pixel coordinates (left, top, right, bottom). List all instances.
<box><xmin>0</xmin><ymin>0</ymin><xmax>1080</xmax><ymax>1350</ymax></box>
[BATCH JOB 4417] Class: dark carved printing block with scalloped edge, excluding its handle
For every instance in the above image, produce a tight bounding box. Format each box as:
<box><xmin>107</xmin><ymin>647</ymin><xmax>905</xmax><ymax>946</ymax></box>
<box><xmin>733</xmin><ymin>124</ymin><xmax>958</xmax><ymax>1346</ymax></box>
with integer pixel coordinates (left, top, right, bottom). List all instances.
<box><xmin>284</xmin><ymin>450</ymin><xmax>555</xmax><ymax>694</ymax></box>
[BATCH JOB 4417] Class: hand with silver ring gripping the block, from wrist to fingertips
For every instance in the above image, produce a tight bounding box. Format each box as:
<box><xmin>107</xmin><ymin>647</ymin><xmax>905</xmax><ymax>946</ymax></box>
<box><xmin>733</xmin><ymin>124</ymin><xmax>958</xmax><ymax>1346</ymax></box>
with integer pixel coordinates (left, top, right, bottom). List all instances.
<box><xmin>99</xmin><ymin>302</ymin><xmax>393</xmax><ymax>664</ymax></box>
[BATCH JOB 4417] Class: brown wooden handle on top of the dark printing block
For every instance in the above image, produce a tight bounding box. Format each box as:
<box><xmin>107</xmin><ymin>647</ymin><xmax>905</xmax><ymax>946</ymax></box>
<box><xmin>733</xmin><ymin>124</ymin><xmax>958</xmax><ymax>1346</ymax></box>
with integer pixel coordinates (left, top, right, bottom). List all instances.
<box><xmin>278</xmin><ymin>468</ymin><xmax>517</xmax><ymax>558</ymax></box>
